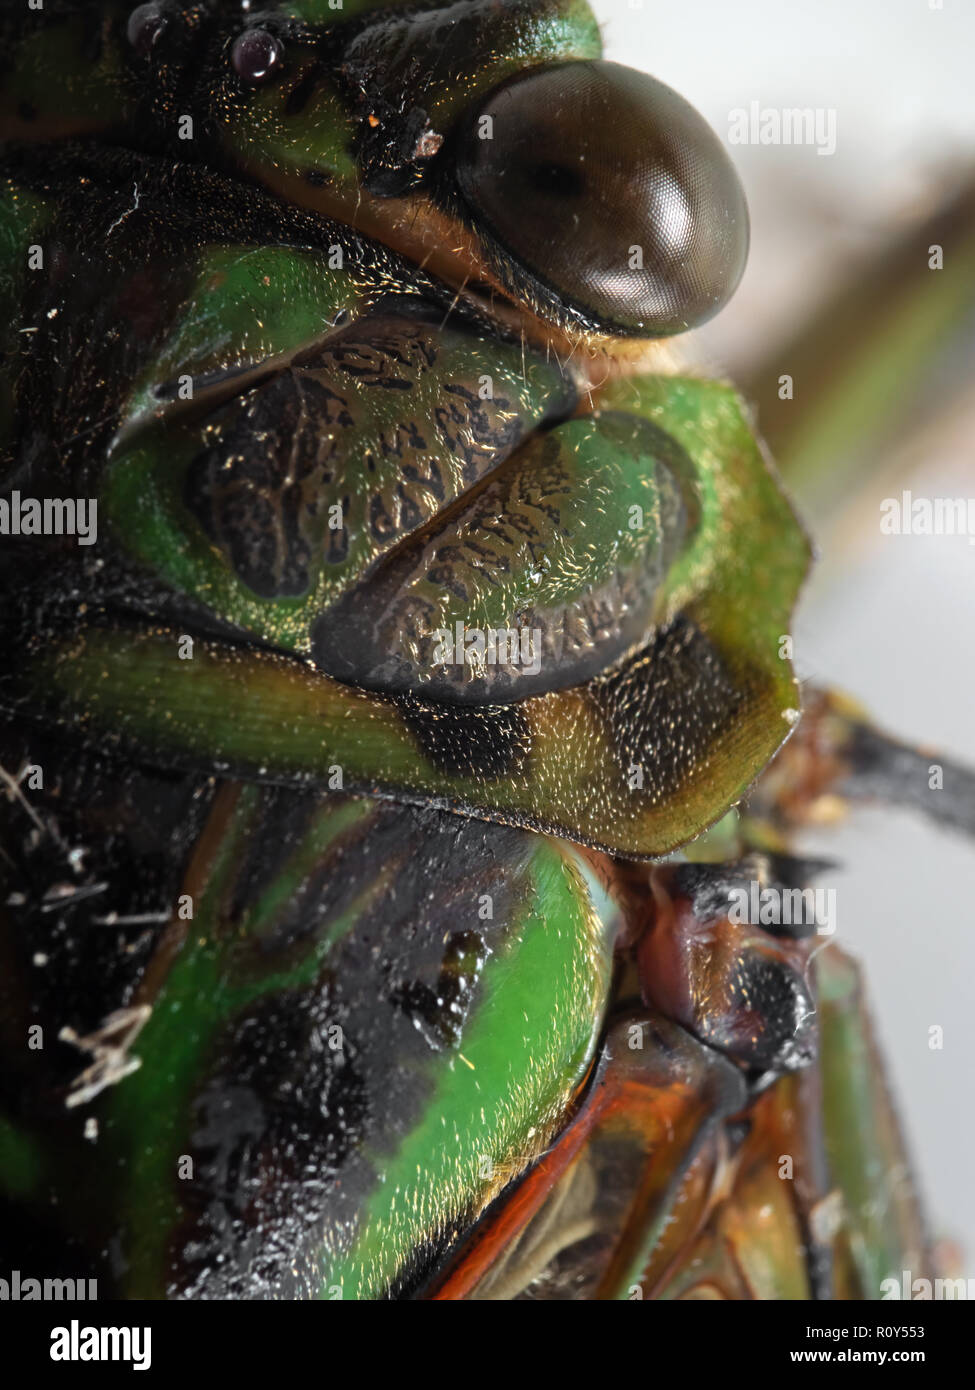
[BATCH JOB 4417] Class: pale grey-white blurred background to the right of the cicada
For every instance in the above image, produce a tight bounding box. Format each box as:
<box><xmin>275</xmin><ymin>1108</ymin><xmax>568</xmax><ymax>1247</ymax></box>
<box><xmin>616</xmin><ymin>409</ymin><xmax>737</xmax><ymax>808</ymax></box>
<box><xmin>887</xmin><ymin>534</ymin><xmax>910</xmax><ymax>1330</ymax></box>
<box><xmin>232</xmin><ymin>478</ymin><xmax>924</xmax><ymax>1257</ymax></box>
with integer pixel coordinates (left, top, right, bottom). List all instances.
<box><xmin>594</xmin><ymin>0</ymin><xmax>975</xmax><ymax>1276</ymax></box>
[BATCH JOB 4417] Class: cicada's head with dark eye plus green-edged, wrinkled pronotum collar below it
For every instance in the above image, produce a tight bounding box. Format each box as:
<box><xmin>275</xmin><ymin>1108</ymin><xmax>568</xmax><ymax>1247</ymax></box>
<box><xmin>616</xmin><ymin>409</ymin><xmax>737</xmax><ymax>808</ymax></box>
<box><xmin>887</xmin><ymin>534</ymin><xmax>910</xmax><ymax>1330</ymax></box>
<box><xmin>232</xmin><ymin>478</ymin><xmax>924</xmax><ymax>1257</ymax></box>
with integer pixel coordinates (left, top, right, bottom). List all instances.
<box><xmin>0</xmin><ymin>0</ymin><xmax>808</xmax><ymax>855</ymax></box>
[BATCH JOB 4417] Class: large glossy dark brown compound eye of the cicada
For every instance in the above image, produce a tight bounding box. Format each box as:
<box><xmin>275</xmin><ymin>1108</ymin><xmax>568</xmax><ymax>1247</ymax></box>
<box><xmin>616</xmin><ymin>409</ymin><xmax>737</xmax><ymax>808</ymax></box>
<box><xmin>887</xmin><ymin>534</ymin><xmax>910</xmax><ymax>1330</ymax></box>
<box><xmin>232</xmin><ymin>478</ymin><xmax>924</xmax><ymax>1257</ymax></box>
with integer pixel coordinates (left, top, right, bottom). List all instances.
<box><xmin>456</xmin><ymin>63</ymin><xmax>748</xmax><ymax>336</ymax></box>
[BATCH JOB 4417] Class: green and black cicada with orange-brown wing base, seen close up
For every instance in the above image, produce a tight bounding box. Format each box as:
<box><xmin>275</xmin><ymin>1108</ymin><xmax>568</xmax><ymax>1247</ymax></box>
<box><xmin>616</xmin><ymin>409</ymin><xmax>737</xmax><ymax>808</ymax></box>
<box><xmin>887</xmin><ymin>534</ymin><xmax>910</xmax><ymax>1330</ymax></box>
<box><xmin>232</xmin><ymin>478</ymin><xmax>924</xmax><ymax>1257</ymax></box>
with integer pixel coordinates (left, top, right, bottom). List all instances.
<box><xmin>0</xmin><ymin>0</ymin><xmax>975</xmax><ymax>1300</ymax></box>
